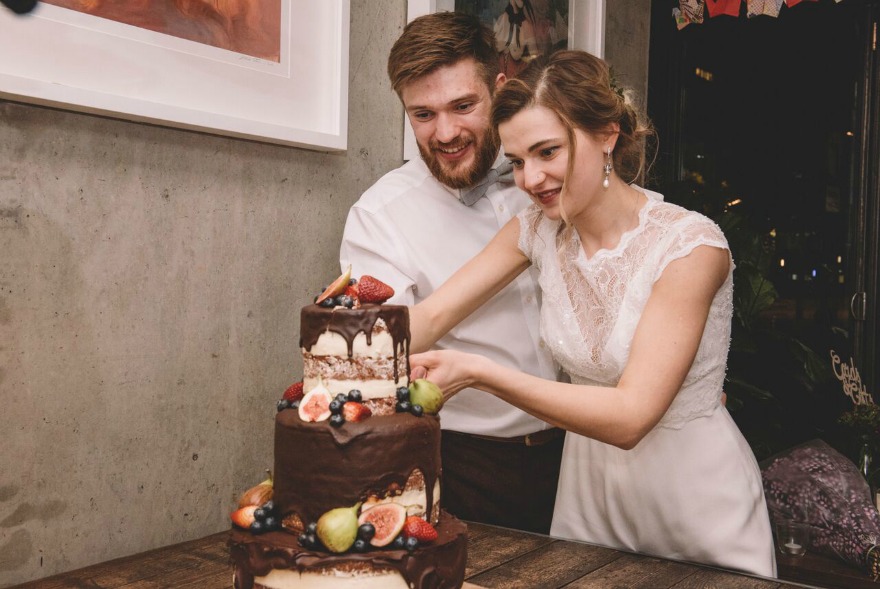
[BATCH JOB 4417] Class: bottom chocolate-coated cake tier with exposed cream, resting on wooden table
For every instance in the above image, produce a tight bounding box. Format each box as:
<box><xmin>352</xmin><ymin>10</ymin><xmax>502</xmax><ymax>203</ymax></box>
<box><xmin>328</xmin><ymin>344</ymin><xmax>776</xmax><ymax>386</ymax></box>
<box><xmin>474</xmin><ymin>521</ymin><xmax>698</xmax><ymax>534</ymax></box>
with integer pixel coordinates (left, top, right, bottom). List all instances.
<box><xmin>229</xmin><ymin>512</ymin><xmax>467</xmax><ymax>589</ymax></box>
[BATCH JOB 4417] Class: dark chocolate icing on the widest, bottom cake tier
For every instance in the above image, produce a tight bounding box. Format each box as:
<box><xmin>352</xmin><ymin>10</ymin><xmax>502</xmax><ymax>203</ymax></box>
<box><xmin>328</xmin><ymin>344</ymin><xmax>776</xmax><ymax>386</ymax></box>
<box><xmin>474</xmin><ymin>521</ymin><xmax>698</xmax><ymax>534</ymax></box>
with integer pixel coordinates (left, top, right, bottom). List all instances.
<box><xmin>228</xmin><ymin>512</ymin><xmax>467</xmax><ymax>589</ymax></box>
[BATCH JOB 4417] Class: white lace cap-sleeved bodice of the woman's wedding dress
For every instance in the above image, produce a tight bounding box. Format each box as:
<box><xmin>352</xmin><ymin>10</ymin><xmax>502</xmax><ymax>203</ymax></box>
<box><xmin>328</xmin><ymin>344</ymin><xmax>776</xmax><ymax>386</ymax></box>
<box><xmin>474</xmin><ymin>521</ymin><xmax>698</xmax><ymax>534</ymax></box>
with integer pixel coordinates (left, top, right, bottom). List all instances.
<box><xmin>519</xmin><ymin>189</ymin><xmax>733</xmax><ymax>428</ymax></box>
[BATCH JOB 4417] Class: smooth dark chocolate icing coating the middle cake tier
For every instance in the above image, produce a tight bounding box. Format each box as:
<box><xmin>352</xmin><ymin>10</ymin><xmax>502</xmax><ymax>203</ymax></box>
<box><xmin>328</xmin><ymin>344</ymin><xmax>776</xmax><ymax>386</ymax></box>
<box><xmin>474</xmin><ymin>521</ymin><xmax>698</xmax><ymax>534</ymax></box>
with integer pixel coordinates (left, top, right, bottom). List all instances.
<box><xmin>273</xmin><ymin>409</ymin><xmax>440</xmax><ymax>525</ymax></box>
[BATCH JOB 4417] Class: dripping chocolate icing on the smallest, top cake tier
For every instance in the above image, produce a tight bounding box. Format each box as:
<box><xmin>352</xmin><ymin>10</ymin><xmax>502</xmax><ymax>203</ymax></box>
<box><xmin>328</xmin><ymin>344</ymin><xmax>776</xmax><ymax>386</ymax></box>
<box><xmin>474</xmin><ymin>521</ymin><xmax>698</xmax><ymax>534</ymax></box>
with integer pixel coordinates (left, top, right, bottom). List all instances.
<box><xmin>299</xmin><ymin>304</ymin><xmax>410</xmax><ymax>382</ymax></box>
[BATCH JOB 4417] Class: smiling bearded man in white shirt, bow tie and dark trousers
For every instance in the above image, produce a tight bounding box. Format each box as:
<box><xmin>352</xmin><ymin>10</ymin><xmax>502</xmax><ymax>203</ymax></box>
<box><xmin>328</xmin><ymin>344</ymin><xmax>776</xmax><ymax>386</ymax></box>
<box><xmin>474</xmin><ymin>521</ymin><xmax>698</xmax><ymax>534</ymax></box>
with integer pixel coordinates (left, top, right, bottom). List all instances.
<box><xmin>340</xmin><ymin>12</ymin><xmax>563</xmax><ymax>533</ymax></box>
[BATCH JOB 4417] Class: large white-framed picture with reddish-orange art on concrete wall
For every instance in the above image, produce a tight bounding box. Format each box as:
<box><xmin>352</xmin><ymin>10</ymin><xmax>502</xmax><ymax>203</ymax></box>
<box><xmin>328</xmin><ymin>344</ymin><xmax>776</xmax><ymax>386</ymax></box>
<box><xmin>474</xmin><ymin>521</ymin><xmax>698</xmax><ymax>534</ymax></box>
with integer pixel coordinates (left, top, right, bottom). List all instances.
<box><xmin>0</xmin><ymin>0</ymin><xmax>350</xmax><ymax>151</ymax></box>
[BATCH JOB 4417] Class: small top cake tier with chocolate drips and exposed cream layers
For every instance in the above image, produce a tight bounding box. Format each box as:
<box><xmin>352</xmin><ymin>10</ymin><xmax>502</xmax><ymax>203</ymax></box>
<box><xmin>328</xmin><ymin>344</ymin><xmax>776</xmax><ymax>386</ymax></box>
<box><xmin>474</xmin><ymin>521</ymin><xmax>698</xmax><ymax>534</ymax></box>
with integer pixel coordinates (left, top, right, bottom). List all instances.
<box><xmin>300</xmin><ymin>304</ymin><xmax>410</xmax><ymax>415</ymax></box>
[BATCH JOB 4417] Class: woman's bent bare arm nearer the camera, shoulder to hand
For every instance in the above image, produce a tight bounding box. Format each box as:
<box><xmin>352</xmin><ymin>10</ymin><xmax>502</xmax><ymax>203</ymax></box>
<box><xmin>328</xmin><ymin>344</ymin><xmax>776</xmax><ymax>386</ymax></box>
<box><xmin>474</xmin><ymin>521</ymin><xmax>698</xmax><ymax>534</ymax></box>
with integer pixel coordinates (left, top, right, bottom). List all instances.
<box><xmin>411</xmin><ymin>246</ymin><xmax>730</xmax><ymax>449</ymax></box>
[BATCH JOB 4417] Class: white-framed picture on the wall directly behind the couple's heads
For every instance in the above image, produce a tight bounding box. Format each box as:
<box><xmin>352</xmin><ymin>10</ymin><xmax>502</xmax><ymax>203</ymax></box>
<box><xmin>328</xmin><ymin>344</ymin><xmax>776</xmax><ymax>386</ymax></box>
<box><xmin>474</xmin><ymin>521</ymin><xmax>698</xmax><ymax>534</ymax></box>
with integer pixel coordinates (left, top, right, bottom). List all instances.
<box><xmin>403</xmin><ymin>0</ymin><xmax>605</xmax><ymax>160</ymax></box>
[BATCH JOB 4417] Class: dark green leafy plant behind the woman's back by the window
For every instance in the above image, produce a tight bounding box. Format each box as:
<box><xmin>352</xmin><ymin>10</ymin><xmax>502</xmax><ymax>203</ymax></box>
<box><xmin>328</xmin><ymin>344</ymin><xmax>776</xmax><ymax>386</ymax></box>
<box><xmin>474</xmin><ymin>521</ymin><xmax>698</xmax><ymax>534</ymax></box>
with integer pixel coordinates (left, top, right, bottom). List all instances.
<box><xmin>666</xmin><ymin>177</ymin><xmax>846</xmax><ymax>460</ymax></box>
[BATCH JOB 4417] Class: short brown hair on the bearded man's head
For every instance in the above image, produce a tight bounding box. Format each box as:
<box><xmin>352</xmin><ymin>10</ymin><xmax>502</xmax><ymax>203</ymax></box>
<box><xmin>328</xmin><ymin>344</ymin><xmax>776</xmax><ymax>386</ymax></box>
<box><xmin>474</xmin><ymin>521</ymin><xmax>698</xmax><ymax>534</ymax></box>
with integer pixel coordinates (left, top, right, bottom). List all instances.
<box><xmin>388</xmin><ymin>12</ymin><xmax>498</xmax><ymax>96</ymax></box>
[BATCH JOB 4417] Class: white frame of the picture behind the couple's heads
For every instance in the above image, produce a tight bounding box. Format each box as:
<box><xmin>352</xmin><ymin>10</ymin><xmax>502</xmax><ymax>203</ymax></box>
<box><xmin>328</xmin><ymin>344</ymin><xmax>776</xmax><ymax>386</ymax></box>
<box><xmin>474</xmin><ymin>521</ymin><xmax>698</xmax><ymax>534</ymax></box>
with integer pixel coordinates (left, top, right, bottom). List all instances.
<box><xmin>403</xmin><ymin>0</ymin><xmax>605</xmax><ymax>160</ymax></box>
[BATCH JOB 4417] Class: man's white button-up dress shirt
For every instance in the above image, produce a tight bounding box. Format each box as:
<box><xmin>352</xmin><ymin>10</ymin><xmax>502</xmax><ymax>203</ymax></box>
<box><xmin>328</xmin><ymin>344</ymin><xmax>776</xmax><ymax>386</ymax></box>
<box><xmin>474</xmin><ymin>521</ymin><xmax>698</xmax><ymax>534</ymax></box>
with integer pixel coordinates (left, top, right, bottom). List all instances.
<box><xmin>339</xmin><ymin>157</ymin><xmax>557</xmax><ymax>437</ymax></box>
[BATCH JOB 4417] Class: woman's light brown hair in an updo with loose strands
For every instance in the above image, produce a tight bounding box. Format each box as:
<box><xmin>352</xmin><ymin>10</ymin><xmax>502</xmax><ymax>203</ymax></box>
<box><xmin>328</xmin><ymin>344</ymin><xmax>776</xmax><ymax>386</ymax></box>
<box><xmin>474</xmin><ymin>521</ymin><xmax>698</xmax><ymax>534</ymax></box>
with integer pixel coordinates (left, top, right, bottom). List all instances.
<box><xmin>492</xmin><ymin>50</ymin><xmax>654</xmax><ymax>184</ymax></box>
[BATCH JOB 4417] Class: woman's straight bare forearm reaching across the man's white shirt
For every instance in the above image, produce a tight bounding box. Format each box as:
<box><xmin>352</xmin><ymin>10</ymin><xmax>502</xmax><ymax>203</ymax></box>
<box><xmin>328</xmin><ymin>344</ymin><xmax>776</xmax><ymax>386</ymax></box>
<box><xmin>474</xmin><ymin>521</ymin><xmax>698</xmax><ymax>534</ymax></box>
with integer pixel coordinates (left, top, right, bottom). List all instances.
<box><xmin>410</xmin><ymin>217</ymin><xmax>530</xmax><ymax>352</ymax></box>
